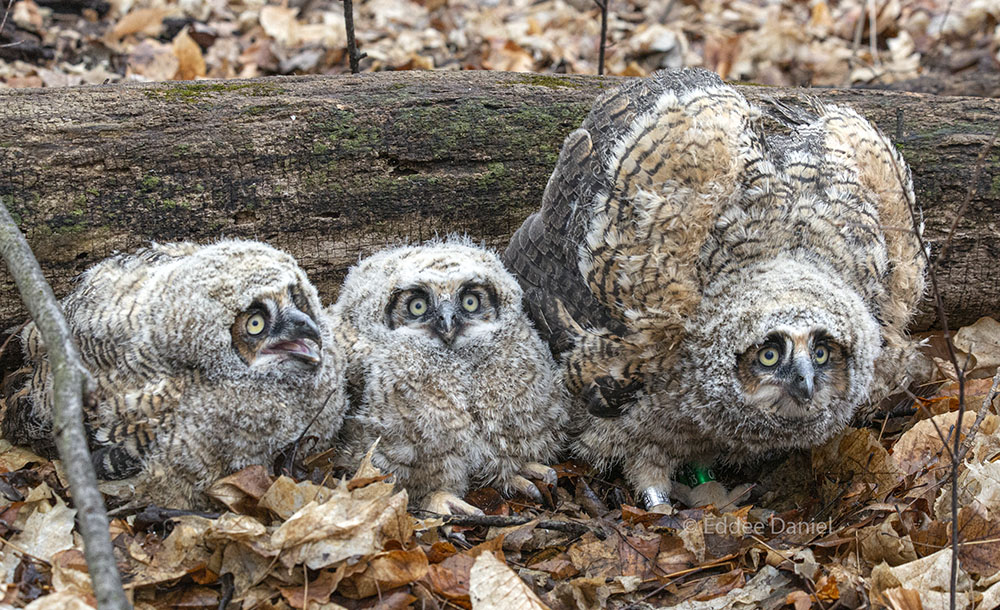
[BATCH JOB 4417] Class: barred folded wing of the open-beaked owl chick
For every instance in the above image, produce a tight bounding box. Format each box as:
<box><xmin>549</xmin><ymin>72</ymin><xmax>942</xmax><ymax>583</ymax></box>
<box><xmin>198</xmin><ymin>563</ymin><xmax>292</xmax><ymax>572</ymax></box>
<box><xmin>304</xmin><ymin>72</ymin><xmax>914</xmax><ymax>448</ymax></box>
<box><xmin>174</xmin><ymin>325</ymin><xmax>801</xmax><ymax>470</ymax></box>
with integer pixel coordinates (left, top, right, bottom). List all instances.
<box><xmin>2</xmin><ymin>244</ymin><xmax>195</xmax><ymax>470</ymax></box>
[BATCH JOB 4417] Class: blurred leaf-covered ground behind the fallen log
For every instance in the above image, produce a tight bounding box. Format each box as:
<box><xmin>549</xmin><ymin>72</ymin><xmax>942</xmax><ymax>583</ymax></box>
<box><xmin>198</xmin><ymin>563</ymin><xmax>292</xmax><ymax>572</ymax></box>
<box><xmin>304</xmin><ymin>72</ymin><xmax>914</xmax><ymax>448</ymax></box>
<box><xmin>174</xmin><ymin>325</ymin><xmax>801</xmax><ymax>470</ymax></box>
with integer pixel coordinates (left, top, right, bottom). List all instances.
<box><xmin>0</xmin><ymin>0</ymin><xmax>1000</xmax><ymax>95</ymax></box>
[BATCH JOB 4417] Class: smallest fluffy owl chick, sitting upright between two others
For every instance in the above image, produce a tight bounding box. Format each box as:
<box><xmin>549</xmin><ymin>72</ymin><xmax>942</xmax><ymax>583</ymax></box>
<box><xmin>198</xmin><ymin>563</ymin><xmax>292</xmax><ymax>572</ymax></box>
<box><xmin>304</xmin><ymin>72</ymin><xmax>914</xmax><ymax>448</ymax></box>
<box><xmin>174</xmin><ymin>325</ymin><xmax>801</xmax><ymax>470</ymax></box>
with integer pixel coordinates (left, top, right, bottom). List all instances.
<box><xmin>332</xmin><ymin>240</ymin><xmax>567</xmax><ymax>512</ymax></box>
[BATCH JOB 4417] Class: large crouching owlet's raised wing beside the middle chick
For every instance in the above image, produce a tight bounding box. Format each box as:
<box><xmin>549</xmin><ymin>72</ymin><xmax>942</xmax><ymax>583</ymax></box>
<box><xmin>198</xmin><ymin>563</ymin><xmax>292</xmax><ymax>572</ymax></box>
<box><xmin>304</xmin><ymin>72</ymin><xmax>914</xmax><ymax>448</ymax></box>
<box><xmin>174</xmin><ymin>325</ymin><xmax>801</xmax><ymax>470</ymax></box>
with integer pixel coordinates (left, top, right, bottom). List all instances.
<box><xmin>504</xmin><ymin>70</ymin><xmax>766</xmax><ymax>415</ymax></box>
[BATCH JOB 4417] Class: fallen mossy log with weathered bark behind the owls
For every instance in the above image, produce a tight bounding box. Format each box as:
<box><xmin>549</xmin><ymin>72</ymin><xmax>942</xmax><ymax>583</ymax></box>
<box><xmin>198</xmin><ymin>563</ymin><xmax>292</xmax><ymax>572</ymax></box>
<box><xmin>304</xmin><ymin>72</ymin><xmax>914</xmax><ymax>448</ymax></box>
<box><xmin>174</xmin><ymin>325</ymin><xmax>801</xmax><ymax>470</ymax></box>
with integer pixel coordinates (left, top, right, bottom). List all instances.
<box><xmin>0</xmin><ymin>72</ymin><xmax>1000</xmax><ymax>338</ymax></box>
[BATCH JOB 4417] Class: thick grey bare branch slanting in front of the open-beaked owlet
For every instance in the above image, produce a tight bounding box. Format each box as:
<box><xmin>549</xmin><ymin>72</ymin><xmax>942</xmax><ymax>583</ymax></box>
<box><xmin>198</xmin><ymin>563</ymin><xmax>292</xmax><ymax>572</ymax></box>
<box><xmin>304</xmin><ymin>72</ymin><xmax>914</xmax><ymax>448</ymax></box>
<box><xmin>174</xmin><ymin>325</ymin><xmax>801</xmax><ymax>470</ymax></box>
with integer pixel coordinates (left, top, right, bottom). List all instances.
<box><xmin>0</xmin><ymin>204</ymin><xmax>131</xmax><ymax>610</ymax></box>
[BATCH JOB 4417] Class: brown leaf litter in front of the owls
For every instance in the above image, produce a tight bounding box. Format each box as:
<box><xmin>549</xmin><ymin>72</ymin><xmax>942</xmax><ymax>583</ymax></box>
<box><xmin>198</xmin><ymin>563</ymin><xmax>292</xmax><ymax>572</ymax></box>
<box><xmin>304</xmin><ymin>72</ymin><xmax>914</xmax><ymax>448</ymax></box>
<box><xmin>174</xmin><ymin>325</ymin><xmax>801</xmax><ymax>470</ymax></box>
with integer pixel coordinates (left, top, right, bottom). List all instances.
<box><xmin>0</xmin><ymin>318</ymin><xmax>1000</xmax><ymax>610</ymax></box>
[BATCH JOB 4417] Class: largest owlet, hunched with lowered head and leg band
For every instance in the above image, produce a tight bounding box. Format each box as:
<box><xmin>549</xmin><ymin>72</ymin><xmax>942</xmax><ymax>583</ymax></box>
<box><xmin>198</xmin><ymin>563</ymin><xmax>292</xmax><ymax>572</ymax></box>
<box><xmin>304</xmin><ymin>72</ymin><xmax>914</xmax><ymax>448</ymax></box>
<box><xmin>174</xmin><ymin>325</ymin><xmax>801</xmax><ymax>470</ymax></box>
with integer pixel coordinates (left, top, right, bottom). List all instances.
<box><xmin>505</xmin><ymin>70</ymin><xmax>924</xmax><ymax>506</ymax></box>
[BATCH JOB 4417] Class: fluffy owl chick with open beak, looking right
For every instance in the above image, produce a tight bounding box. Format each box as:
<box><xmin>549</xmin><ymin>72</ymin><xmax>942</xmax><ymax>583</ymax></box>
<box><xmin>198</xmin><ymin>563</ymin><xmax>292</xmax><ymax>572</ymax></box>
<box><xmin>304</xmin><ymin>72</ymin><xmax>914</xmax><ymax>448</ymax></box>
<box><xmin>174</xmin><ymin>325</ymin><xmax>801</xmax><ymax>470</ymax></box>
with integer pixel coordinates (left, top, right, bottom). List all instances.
<box><xmin>3</xmin><ymin>241</ymin><xmax>346</xmax><ymax>508</ymax></box>
